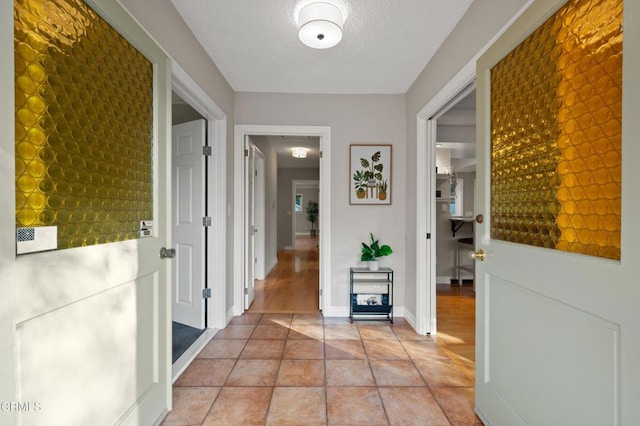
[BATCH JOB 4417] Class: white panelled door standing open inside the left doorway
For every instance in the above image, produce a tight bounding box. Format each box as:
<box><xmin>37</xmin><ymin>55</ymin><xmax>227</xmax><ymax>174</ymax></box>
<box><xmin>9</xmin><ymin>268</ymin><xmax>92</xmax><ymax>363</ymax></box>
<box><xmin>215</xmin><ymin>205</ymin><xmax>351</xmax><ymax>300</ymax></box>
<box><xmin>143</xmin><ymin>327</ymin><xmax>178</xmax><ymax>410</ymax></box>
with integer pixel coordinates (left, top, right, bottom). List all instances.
<box><xmin>172</xmin><ymin>119</ymin><xmax>206</xmax><ymax>329</ymax></box>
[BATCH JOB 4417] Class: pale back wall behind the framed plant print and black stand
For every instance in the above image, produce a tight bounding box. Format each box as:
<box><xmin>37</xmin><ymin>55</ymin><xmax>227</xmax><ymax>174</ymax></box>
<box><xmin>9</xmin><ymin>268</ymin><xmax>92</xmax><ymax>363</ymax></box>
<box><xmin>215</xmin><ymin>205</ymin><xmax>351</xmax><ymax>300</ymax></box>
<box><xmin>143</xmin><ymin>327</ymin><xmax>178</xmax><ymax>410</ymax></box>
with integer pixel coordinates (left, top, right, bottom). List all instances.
<box><xmin>234</xmin><ymin>93</ymin><xmax>404</xmax><ymax>314</ymax></box>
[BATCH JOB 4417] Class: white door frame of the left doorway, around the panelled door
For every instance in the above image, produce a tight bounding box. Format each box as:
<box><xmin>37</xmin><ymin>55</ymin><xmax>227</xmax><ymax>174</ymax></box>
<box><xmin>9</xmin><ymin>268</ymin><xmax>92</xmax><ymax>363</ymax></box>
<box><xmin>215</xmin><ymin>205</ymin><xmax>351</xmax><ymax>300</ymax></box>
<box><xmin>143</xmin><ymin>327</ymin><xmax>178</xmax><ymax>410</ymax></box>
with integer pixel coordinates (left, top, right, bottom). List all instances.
<box><xmin>172</xmin><ymin>62</ymin><xmax>227</xmax><ymax>380</ymax></box>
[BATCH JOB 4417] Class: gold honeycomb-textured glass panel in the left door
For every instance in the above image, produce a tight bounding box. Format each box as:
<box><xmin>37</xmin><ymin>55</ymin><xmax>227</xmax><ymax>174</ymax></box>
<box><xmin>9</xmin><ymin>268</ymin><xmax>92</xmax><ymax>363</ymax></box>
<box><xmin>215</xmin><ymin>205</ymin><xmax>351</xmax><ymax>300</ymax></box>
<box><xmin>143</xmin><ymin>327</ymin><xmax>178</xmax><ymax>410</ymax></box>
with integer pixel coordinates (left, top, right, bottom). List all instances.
<box><xmin>14</xmin><ymin>0</ymin><xmax>153</xmax><ymax>249</ymax></box>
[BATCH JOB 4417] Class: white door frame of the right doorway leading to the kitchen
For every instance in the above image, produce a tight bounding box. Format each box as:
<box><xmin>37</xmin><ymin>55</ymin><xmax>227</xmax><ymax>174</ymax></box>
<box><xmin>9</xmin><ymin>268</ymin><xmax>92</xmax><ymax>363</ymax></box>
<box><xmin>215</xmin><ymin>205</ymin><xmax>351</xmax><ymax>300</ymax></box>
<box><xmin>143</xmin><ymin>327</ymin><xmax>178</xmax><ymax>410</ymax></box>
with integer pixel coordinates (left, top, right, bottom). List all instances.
<box><xmin>415</xmin><ymin>4</ymin><xmax>533</xmax><ymax>335</ymax></box>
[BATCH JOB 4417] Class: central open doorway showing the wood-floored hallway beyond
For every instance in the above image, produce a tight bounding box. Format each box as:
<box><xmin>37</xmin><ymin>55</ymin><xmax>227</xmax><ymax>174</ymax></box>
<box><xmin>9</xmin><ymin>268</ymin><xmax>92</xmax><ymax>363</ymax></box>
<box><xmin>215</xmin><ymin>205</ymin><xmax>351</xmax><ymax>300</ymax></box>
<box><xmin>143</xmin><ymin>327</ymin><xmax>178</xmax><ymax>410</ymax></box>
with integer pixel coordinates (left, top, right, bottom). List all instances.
<box><xmin>245</xmin><ymin>135</ymin><xmax>320</xmax><ymax>313</ymax></box>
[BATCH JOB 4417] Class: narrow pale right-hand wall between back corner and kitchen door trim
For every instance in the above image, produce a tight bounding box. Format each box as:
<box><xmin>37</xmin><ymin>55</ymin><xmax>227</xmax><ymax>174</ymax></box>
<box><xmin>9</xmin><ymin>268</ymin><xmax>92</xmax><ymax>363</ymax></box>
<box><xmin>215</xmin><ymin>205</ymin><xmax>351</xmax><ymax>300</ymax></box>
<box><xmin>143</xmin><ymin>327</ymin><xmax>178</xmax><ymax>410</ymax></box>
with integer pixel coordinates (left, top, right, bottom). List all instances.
<box><xmin>404</xmin><ymin>0</ymin><xmax>527</xmax><ymax>320</ymax></box>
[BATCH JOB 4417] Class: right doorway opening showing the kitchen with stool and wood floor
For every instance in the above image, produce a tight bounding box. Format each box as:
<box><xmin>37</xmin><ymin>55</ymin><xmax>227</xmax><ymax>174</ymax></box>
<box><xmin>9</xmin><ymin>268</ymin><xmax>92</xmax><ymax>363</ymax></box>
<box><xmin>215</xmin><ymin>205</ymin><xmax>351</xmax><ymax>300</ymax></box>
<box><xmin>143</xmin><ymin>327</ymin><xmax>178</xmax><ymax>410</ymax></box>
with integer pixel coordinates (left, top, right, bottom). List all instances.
<box><xmin>429</xmin><ymin>83</ymin><xmax>476</xmax><ymax>377</ymax></box>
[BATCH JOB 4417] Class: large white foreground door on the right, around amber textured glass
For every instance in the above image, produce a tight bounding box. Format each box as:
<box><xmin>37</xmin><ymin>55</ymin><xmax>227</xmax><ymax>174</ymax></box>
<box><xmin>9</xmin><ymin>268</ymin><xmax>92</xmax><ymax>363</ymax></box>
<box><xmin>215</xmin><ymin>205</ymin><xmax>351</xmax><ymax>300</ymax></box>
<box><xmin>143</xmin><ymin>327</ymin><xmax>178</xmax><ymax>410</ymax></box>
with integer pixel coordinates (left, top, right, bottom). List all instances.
<box><xmin>475</xmin><ymin>0</ymin><xmax>640</xmax><ymax>425</ymax></box>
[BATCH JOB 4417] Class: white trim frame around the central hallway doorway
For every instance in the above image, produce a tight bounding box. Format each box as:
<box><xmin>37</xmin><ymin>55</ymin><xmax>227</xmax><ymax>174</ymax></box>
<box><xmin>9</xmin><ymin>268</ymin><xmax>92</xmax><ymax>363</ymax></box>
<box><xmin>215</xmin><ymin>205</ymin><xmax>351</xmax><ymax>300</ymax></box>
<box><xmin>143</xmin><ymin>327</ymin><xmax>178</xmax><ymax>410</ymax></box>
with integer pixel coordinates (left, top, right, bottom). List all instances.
<box><xmin>233</xmin><ymin>125</ymin><xmax>331</xmax><ymax>315</ymax></box>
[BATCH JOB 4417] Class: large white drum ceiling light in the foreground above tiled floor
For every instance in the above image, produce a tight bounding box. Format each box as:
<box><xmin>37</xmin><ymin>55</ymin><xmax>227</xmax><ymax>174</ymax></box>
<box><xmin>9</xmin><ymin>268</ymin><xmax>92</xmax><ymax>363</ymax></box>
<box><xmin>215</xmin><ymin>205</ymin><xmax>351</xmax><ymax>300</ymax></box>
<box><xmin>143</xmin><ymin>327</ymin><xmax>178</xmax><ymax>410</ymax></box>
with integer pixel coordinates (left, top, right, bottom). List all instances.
<box><xmin>298</xmin><ymin>1</ymin><xmax>344</xmax><ymax>49</ymax></box>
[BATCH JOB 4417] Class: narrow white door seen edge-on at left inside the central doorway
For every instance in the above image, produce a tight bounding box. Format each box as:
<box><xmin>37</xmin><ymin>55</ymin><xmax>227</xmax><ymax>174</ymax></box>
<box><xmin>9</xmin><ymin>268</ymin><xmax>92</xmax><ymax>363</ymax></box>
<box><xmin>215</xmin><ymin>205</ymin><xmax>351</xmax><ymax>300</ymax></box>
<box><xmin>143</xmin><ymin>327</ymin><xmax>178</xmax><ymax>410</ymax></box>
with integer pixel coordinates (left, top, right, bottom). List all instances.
<box><xmin>244</xmin><ymin>137</ymin><xmax>256</xmax><ymax>309</ymax></box>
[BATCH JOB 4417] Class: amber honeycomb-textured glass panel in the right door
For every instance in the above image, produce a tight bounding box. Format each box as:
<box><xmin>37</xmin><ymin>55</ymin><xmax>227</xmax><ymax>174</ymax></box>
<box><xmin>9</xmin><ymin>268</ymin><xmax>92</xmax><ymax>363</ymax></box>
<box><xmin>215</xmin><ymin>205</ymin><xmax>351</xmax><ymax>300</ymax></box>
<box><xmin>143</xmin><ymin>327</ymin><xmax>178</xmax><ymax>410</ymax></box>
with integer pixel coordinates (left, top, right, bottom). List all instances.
<box><xmin>491</xmin><ymin>0</ymin><xmax>622</xmax><ymax>260</ymax></box>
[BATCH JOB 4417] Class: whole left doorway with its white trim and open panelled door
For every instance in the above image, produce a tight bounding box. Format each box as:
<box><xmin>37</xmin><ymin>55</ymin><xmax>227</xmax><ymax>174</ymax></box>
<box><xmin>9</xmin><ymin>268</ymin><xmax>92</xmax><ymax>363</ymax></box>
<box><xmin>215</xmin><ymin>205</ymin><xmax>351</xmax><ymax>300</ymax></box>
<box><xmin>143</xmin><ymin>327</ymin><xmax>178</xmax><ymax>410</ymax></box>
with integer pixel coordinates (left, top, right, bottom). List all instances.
<box><xmin>171</xmin><ymin>62</ymin><xmax>227</xmax><ymax>380</ymax></box>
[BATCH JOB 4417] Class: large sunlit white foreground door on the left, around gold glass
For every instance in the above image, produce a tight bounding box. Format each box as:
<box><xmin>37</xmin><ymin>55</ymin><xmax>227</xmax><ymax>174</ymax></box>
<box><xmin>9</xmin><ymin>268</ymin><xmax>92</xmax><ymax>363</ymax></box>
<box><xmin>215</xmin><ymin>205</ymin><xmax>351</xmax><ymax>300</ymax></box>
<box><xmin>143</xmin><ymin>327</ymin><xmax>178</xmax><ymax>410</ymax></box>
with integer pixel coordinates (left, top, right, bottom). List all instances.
<box><xmin>11</xmin><ymin>0</ymin><xmax>171</xmax><ymax>425</ymax></box>
